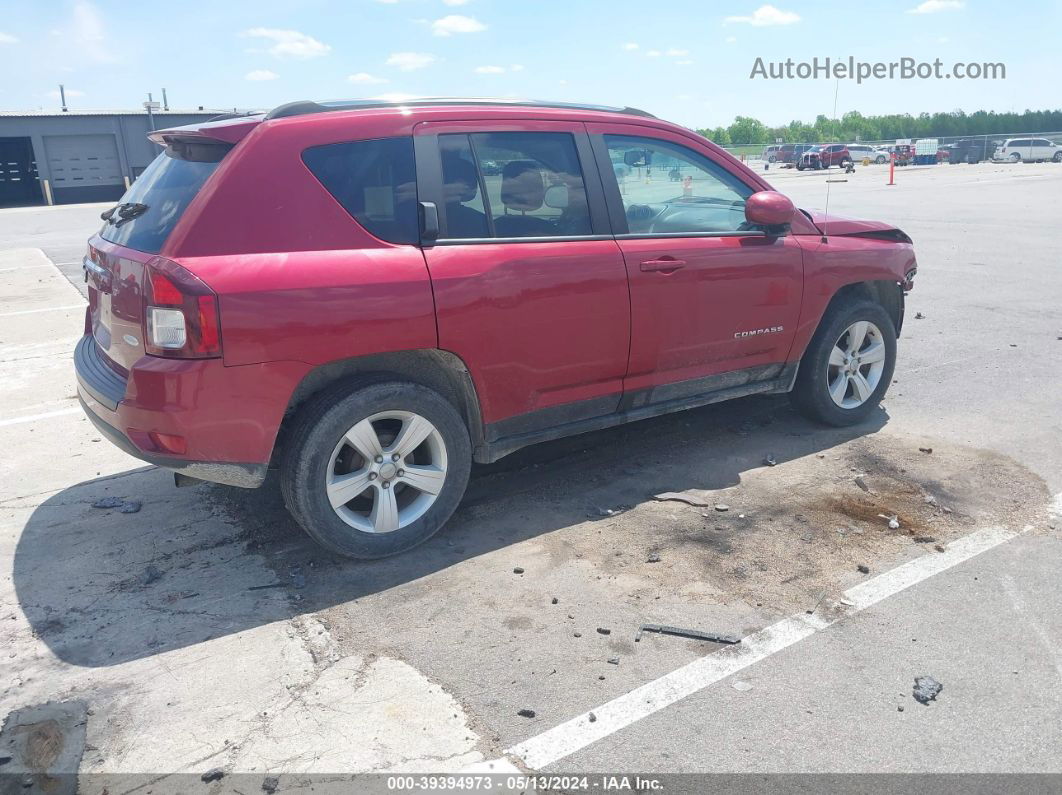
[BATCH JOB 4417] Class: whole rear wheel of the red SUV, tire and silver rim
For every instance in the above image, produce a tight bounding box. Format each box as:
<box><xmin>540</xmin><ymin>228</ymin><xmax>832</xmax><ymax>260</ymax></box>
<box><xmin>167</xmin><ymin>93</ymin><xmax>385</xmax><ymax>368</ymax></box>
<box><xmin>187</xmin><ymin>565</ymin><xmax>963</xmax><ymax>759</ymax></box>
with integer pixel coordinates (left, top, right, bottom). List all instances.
<box><xmin>280</xmin><ymin>380</ymin><xmax>472</xmax><ymax>559</ymax></box>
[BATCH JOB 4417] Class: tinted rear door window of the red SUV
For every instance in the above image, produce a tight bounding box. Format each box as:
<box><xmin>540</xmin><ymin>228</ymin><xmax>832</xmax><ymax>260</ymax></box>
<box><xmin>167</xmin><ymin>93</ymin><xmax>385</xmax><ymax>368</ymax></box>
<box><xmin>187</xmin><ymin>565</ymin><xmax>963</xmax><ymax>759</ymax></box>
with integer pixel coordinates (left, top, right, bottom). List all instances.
<box><xmin>439</xmin><ymin>133</ymin><xmax>592</xmax><ymax>240</ymax></box>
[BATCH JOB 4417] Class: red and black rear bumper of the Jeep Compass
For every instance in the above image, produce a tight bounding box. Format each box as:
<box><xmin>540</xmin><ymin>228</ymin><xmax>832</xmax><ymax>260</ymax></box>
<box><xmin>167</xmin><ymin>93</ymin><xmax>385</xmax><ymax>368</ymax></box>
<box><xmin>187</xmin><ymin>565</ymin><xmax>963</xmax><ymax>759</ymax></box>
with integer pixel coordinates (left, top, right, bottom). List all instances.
<box><xmin>74</xmin><ymin>334</ymin><xmax>303</xmax><ymax>488</ymax></box>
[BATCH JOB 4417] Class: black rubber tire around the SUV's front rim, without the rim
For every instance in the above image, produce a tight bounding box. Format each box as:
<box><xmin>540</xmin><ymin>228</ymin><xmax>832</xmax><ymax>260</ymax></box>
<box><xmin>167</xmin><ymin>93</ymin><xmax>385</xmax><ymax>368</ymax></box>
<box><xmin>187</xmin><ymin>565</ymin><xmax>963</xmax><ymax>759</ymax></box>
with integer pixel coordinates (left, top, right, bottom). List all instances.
<box><xmin>789</xmin><ymin>299</ymin><xmax>896</xmax><ymax>427</ymax></box>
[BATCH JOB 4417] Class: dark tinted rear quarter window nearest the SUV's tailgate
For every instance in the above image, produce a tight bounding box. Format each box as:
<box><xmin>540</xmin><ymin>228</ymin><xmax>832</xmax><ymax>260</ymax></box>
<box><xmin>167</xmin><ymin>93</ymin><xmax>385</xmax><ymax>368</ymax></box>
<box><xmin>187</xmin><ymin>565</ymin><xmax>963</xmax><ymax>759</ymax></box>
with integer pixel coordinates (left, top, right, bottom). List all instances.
<box><xmin>303</xmin><ymin>138</ymin><xmax>419</xmax><ymax>243</ymax></box>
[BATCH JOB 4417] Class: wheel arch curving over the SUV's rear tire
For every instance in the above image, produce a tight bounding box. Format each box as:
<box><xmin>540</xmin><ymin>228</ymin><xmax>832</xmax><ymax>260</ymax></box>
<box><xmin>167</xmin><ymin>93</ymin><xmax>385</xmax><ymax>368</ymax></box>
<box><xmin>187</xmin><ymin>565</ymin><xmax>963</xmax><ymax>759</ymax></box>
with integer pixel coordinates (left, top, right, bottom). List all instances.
<box><xmin>273</xmin><ymin>348</ymin><xmax>484</xmax><ymax>462</ymax></box>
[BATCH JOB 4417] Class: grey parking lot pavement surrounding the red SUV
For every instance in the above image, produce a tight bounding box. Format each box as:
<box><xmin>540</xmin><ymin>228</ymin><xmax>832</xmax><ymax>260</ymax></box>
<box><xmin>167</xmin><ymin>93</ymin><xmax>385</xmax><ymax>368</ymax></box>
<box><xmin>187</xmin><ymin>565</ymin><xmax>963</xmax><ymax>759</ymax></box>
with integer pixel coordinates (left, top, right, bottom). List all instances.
<box><xmin>0</xmin><ymin>163</ymin><xmax>1062</xmax><ymax>789</ymax></box>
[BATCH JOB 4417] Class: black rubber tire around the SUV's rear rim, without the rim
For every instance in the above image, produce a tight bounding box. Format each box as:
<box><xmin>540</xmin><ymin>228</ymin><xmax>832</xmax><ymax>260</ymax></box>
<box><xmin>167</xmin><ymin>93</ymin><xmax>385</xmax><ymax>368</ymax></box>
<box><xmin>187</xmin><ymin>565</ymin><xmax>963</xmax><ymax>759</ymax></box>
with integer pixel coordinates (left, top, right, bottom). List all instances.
<box><xmin>280</xmin><ymin>377</ymin><xmax>472</xmax><ymax>559</ymax></box>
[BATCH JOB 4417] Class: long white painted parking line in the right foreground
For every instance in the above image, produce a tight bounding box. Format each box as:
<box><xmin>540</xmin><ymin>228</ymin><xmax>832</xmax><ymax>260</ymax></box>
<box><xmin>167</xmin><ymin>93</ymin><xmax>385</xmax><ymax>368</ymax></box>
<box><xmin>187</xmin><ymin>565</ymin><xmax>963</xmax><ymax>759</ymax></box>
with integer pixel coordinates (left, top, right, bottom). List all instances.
<box><xmin>504</xmin><ymin>515</ymin><xmax>1040</xmax><ymax>770</ymax></box>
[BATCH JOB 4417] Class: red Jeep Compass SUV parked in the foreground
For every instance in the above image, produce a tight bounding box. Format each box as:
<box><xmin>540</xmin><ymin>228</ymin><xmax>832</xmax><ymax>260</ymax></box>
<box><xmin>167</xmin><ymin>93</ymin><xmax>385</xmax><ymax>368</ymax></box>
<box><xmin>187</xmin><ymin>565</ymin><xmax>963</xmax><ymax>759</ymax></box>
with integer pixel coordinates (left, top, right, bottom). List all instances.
<box><xmin>75</xmin><ymin>100</ymin><xmax>915</xmax><ymax>558</ymax></box>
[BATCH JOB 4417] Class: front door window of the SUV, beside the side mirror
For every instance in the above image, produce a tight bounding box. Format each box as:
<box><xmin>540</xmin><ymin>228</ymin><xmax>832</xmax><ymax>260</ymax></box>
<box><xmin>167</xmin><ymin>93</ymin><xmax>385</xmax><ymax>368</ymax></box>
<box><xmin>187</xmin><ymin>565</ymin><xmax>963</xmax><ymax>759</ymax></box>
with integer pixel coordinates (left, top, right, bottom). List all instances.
<box><xmin>604</xmin><ymin>135</ymin><xmax>753</xmax><ymax>236</ymax></box>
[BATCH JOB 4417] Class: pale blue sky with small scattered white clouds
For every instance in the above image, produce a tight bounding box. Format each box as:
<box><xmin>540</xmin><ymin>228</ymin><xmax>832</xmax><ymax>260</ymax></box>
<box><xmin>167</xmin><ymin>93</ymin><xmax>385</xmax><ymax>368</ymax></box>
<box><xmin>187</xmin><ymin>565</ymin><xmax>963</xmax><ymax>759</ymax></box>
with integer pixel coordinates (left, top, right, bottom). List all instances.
<box><xmin>0</xmin><ymin>0</ymin><xmax>1062</xmax><ymax>127</ymax></box>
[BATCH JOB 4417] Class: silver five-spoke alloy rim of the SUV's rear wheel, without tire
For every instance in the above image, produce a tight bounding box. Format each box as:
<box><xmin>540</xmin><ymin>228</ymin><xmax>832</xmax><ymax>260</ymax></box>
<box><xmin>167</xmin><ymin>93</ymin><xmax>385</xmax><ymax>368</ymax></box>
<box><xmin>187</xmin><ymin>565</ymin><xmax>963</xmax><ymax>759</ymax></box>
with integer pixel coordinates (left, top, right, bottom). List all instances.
<box><xmin>325</xmin><ymin>411</ymin><xmax>446</xmax><ymax>533</ymax></box>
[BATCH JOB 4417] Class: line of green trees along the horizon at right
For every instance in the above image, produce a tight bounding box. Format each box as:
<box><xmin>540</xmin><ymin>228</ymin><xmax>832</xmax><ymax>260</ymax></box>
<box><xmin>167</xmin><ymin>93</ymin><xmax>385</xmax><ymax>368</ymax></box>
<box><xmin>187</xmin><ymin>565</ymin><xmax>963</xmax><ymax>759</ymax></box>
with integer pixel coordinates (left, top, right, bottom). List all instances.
<box><xmin>697</xmin><ymin>110</ymin><xmax>1062</xmax><ymax>146</ymax></box>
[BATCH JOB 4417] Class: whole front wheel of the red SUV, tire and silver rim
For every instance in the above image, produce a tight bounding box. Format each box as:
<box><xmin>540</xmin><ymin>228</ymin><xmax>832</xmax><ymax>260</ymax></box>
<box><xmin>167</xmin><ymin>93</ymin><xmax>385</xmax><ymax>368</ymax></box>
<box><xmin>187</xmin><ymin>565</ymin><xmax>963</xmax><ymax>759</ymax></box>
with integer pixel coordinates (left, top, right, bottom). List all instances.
<box><xmin>790</xmin><ymin>300</ymin><xmax>896</xmax><ymax>426</ymax></box>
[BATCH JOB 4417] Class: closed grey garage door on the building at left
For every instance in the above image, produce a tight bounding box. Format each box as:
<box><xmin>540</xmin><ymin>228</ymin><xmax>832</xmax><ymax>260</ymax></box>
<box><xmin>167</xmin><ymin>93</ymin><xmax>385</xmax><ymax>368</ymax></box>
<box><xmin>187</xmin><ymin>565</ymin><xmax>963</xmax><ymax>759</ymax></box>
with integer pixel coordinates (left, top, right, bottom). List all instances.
<box><xmin>45</xmin><ymin>134</ymin><xmax>125</xmax><ymax>204</ymax></box>
